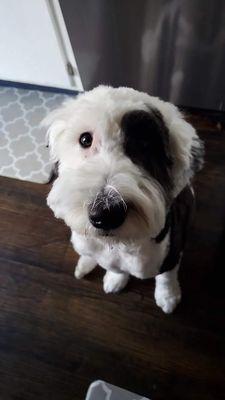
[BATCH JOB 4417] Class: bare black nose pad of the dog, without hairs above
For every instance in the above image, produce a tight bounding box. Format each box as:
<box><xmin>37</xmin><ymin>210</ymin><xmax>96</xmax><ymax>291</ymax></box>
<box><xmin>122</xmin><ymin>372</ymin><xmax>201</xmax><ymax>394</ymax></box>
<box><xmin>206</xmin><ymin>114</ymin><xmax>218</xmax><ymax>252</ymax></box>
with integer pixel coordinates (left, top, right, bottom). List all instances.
<box><xmin>89</xmin><ymin>201</ymin><xmax>127</xmax><ymax>231</ymax></box>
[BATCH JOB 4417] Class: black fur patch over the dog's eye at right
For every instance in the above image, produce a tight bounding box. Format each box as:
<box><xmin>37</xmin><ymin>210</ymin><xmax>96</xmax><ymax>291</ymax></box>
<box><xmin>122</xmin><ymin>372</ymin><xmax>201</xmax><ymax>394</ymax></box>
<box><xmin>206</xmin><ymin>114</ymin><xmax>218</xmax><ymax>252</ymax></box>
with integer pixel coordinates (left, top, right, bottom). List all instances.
<box><xmin>121</xmin><ymin>109</ymin><xmax>172</xmax><ymax>190</ymax></box>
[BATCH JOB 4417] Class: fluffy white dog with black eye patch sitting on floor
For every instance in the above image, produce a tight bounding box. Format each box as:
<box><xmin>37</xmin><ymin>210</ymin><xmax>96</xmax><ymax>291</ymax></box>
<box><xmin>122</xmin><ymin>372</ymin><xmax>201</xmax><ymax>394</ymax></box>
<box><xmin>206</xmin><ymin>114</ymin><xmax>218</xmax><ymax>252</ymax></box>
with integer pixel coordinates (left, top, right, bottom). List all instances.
<box><xmin>45</xmin><ymin>85</ymin><xmax>204</xmax><ymax>313</ymax></box>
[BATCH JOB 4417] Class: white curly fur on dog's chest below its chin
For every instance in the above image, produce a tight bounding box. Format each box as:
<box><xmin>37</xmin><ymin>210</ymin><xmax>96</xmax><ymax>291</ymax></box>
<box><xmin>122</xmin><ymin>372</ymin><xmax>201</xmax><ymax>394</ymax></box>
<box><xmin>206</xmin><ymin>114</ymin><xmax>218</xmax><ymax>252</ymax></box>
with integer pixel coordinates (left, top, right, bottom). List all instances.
<box><xmin>72</xmin><ymin>232</ymin><xmax>168</xmax><ymax>279</ymax></box>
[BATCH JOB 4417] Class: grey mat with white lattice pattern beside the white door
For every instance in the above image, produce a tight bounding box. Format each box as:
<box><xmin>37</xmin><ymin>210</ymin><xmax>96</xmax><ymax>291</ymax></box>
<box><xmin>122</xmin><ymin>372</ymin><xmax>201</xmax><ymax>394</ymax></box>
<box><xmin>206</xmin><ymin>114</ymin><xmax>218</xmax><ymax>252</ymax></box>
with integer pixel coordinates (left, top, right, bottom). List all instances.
<box><xmin>0</xmin><ymin>87</ymin><xmax>73</xmax><ymax>183</ymax></box>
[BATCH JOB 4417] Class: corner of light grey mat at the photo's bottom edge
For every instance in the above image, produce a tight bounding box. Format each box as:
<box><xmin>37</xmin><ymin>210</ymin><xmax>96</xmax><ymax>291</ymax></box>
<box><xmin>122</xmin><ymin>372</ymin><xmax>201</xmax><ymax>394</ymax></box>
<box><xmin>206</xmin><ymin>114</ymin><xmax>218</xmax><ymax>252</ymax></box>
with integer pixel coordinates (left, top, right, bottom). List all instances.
<box><xmin>86</xmin><ymin>380</ymin><xmax>150</xmax><ymax>400</ymax></box>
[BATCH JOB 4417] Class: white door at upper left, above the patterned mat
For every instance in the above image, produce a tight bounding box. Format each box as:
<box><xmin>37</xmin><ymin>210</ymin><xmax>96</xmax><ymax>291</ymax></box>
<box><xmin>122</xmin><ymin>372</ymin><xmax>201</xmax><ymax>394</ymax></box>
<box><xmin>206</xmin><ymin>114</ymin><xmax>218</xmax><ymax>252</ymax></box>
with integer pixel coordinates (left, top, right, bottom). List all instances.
<box><xmin>0</xmin><ymin>0</ymin><xmax>82</xmax><ymax>90</ymax></box>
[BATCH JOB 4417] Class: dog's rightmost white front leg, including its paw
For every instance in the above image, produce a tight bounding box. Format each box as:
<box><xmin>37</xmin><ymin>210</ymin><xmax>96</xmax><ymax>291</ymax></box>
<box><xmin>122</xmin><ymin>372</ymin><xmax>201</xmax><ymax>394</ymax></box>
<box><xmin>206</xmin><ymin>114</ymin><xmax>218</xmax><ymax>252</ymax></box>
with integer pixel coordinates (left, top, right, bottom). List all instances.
<box><xmin>155</xmin><ymin>265</ymin><xmax>181</xmax><ymax>314</ymax></box>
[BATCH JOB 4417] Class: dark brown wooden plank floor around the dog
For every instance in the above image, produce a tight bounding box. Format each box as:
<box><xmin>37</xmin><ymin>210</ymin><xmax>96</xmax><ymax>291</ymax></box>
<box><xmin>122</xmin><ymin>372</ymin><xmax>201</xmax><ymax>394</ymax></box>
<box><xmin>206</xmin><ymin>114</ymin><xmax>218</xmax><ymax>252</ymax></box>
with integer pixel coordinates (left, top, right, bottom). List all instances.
<box><xmin>0</xmin><ymin>111</ymin><xmax>225</xmax><ymax>400</ymax></box>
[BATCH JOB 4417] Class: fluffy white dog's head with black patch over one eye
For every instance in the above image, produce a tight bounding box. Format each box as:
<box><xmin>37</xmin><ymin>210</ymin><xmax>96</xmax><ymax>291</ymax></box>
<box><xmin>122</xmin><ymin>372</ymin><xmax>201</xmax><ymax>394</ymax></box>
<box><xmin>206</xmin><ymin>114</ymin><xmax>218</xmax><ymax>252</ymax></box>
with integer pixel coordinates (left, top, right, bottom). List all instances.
<box><xmin>45</xmin><ymin>86</ymin><xmax>204</xmax><ymax>241</ymax></box>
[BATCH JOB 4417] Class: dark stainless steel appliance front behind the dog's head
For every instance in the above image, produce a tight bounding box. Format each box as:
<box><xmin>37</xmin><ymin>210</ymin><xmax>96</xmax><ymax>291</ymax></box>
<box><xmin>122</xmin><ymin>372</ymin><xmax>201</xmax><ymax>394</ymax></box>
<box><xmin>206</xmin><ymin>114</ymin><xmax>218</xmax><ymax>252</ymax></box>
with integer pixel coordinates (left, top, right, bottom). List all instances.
<box><xmin>60</xmin><ymin>0</ymin><xmax>225</xmax><ymax>110</ymax></box>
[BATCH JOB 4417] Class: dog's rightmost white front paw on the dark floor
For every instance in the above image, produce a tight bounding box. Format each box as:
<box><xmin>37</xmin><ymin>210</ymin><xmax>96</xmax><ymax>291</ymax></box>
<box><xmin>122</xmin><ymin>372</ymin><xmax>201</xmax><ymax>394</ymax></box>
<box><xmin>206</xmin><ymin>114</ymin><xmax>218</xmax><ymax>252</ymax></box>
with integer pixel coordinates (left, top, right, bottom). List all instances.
<box><xmin>155</xmin><ymin>286</ymin><xmax>181</xmax><ymax>314</ymax></box>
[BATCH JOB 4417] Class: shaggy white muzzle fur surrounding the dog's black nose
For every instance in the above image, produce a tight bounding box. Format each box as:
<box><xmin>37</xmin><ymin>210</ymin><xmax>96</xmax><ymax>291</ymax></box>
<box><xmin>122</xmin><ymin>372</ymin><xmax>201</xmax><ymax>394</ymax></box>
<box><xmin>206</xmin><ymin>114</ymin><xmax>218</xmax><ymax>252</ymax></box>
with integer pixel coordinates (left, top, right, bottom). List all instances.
<box><xmin>47</xmin><ymin>162</ymin><xmax>166</xmax><ymax>242</ymax></box>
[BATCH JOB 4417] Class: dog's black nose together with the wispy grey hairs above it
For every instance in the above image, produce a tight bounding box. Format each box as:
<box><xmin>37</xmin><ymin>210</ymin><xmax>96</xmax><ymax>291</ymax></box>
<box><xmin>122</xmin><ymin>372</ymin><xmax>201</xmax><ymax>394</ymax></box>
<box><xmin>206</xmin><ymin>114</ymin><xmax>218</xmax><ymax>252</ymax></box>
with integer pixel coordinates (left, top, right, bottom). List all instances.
<box><xmin>88</xmin><ymin>190</ymin><xmax>127</xmax><ymax>231</ymax></box>
